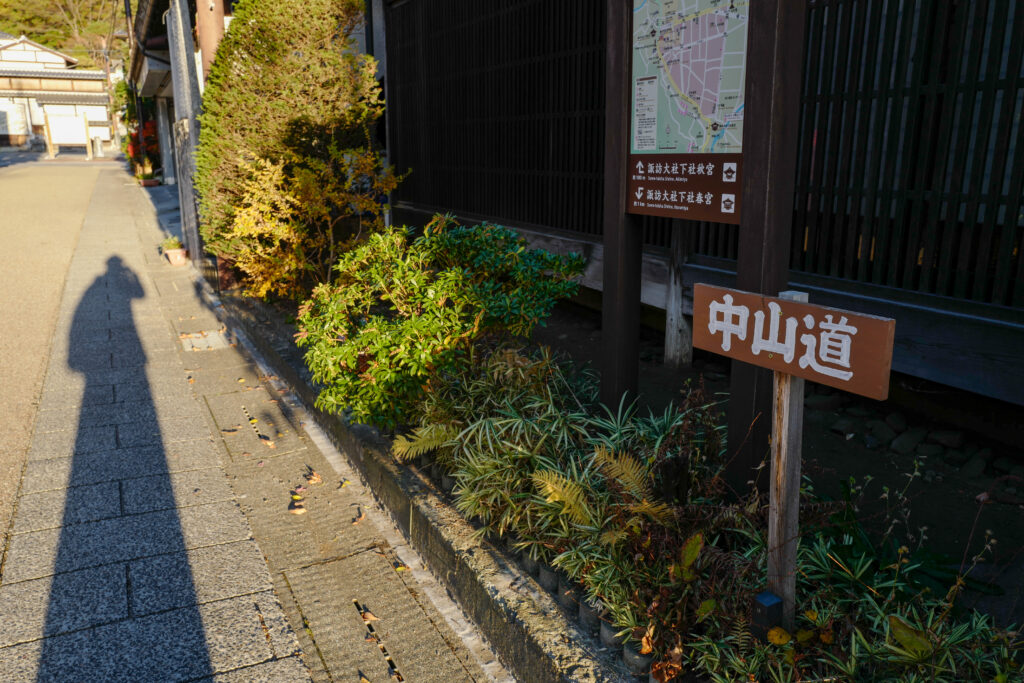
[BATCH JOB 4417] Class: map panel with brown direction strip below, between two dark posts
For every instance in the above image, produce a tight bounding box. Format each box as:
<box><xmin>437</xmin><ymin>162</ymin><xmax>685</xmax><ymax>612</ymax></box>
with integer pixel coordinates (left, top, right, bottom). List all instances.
<box><xmin>628</xmin><ymin>0</ymin><xmax>749</xmax><ymax>224</ymax></box>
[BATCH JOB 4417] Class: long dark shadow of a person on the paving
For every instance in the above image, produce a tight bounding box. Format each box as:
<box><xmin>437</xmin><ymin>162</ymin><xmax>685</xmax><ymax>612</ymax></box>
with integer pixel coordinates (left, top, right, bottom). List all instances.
<box><xmin>37</xmin><ymin>256</ymin><xmax>212</xmax><ymax>681</ymax></box>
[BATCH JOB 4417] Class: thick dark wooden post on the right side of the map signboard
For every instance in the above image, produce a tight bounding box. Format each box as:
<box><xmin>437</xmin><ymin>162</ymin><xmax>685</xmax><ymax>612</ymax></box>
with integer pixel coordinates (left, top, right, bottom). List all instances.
<box><xmin>726</xmin><ymin>0</ymin><xmax>807</xmax><ymax>494</ymax></box>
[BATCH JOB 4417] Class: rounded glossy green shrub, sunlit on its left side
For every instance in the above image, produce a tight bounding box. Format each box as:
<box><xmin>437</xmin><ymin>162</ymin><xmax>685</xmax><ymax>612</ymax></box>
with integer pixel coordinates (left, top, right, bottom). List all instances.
<box><xmin>297</xmin><ymin>216</ymin><xmax>583</xmax><ymax>429</ymax></box>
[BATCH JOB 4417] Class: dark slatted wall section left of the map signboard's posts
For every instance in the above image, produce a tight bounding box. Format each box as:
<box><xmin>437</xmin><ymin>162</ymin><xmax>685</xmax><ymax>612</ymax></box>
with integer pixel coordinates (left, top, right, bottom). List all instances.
<box><xmin>387</xmin><ymin>0</ymin><xmax>605</xmax><ymax>239</ymax></box>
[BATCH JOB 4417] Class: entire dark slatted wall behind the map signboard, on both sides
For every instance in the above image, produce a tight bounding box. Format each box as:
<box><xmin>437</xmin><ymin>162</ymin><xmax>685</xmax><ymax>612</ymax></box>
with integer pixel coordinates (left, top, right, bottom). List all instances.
<box><xmin>387</xmin><ymin>0</ymin><xmax>1024</xmax><ymax>307</ymax></box>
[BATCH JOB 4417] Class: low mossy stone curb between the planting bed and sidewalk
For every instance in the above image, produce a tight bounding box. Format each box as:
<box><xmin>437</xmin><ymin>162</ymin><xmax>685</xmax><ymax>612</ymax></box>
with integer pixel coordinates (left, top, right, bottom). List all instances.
<box><xmin>196</xmin><ymin>273</ymin><xmax>630</xmax><ymax>682</ymax></box>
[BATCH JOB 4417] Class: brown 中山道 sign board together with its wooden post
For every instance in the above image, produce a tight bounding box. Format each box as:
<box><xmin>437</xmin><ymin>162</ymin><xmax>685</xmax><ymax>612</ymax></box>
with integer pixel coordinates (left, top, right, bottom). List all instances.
<box><xmin>693</xmin><ymin>285</ymin><xmax>896</xmax><ymax>629</ymax></box>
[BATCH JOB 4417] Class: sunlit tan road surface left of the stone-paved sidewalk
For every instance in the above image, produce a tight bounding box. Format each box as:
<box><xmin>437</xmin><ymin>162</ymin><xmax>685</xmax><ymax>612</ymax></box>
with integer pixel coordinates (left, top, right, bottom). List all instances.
<box><xmin>0</xmin><ymin>160</ymin><xmax>101</xmax><ymax>557</ymax></box>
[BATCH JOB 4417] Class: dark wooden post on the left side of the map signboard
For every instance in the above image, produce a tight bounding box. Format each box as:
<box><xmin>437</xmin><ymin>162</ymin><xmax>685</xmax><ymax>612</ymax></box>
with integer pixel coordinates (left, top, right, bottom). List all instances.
<box><xmin>601</xmin><ymin>0</ymin><xmax>643</xmax><ymax>410</ymax></box>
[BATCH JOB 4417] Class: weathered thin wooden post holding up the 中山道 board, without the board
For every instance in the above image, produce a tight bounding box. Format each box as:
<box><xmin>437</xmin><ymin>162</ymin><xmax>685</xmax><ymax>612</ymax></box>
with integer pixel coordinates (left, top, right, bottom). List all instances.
<box><xmin>768</xmin><ymin>291</ymin><xmax>807</xmax><ymax>632</ymax></box>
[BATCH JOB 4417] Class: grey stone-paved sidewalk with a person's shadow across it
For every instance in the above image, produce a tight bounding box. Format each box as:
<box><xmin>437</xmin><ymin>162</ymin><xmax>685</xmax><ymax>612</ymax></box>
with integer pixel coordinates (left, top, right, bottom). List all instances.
<box><xmin>0</xmin><ymin>167</ymin><xmax>507</xmax><ymax>683</ymax></box>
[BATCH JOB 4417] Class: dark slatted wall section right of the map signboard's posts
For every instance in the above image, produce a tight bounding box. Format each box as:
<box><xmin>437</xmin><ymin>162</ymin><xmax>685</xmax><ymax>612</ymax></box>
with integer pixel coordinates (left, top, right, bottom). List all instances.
<box><xmin>791</xmin><ymin>0</ymin><xmax>1024</xmax><ymax>307</ymax></box>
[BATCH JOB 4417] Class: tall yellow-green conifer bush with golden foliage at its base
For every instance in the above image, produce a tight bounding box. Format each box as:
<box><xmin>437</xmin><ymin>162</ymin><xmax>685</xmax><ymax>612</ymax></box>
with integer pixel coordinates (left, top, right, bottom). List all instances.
<box><xmin>196</xmin><ymin>0</ymin><xmax>398</xmax><ymax>298</ymax></box>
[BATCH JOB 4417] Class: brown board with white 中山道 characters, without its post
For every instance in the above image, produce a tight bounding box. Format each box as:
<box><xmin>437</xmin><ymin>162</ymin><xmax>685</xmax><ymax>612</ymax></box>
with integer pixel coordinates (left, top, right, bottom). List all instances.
<box><xmin>693</xmin><ymin>284</ymin><xmax>896</xmax><ymax>400</ymax></box>
